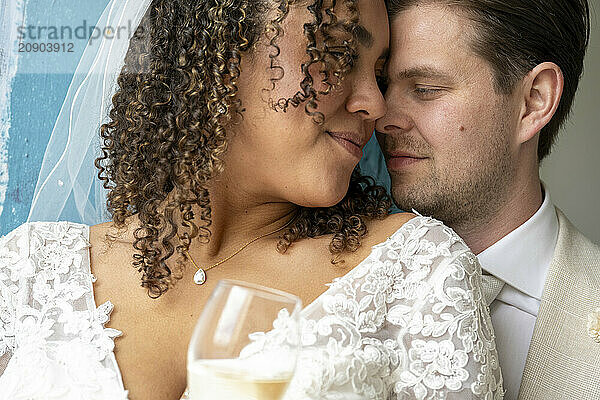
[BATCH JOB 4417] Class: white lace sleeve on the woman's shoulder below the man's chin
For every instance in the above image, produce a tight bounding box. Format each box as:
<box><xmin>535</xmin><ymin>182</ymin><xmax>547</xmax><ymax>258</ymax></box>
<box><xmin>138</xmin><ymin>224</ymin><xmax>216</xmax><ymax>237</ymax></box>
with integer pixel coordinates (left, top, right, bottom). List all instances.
<box><xmin>286</xmin><ymin>216</ymin><xmax>503</xmax><ymax>399</ymax></box>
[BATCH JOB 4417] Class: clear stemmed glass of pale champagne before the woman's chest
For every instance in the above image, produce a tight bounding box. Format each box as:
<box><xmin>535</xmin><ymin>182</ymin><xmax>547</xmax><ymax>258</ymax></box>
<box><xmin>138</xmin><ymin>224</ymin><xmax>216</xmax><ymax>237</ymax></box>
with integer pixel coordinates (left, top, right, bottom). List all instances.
<box><xmin>187</xmin><ymin>280</ymin><xmax>302</xmax><ymax>400</ymax></box>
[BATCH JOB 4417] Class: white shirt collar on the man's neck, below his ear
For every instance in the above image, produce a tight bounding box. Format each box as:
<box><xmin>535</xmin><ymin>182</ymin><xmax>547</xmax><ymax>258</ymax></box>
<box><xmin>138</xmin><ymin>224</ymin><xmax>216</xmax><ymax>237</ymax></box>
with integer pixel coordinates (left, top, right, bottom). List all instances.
<box><xmin>477</xmin><ymin>186</ymin><xmax>558</xmax><ymax>300</ymax></box>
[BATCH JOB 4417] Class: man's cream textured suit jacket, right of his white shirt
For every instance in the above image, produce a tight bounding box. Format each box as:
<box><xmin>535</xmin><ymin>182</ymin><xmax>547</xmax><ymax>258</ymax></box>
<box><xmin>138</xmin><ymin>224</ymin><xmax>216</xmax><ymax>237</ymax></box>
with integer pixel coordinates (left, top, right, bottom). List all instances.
<box><xmin>519</xmin><ymin>208</ymin><xmax>600</xmax><ymax>400</ymax></box>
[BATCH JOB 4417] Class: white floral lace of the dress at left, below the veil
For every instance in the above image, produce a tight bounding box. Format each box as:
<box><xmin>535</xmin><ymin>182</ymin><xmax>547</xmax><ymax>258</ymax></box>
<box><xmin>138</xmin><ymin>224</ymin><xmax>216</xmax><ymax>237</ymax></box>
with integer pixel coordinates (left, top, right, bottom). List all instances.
<box><xmin>0</xmin><ymin>222</ymin><xmax>127</xmax><ymax>400</ymax></box>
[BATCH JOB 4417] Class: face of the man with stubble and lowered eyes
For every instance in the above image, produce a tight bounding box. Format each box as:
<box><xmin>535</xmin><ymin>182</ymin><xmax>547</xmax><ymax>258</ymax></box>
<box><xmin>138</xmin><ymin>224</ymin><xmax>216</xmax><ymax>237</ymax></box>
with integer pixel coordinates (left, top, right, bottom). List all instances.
<box><xmin>377</xmin><ymin>5</ymin><xmax>519</xmax><ymax>225</ymax></box>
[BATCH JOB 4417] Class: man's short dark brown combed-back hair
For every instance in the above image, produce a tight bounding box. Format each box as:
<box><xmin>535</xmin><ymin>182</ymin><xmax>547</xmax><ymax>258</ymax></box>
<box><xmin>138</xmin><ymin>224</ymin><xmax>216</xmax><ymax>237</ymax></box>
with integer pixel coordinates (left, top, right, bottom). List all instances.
<box><xmin>387</xmin><ymin>0</ymin><xmax>590</xmax><ymax>160</ymax></box>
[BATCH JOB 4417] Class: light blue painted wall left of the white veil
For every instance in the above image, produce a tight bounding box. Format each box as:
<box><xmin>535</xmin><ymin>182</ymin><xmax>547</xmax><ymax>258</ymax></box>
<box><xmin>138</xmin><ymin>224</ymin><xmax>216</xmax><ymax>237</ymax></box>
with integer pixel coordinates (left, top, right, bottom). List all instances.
<box><xmin>0</xmin><ymin>0</ymin><xmax>108</xmax><ymax>235</ymax></box>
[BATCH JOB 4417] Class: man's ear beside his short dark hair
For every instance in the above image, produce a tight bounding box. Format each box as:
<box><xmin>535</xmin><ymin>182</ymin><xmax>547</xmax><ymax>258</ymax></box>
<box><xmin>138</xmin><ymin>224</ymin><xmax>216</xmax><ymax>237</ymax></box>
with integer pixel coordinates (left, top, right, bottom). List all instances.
<box><xmin>518</xmin><ymin>62</ymin><xmax>564</xmax><ymax>143</ymax></box>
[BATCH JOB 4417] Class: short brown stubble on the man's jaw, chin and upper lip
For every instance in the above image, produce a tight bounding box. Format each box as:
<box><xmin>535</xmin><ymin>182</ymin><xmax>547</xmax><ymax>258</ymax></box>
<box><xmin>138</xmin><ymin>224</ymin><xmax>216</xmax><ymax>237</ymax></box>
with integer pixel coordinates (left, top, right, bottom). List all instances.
<box><xmin>382</xmin><ymin>111</ymin><xmax>515</xmax><ymax>230</ymax></box>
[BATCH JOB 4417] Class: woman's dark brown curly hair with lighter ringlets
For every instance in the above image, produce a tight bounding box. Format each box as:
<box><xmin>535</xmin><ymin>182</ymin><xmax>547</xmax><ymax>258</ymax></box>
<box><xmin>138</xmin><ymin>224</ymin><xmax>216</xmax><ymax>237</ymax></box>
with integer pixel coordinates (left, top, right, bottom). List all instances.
<box><xmin>95</xmin><ymin>0</ymin><xmax>391</xmax><ymax>298</ymax></box>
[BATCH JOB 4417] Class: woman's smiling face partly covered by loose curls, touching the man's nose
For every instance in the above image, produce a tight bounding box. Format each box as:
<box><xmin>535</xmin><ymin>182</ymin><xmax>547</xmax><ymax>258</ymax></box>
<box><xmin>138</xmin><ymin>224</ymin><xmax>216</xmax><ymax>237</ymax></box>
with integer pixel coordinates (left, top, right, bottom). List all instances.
<box><xmin>224</xmin><ymin>0</ymin><xmax>389</xmax><ymax>207</ymax></box>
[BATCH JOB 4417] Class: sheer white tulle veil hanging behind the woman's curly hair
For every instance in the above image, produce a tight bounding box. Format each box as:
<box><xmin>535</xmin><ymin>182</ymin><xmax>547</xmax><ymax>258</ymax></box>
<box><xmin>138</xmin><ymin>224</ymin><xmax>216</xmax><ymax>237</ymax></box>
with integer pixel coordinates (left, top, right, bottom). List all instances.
<box><xmin>27</xmin><ymin>0</ymin><xmax>151</xmax><ymax>225</ymax></box>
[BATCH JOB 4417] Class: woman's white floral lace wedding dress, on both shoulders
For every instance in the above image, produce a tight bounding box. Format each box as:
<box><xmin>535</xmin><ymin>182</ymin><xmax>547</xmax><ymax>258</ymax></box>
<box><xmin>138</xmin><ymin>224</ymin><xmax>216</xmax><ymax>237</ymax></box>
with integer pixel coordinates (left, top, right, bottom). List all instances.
<box><xmin>0</xmin><ymin>216</ymin><xmax>503</xmax><ymax>400</ymax></box>
